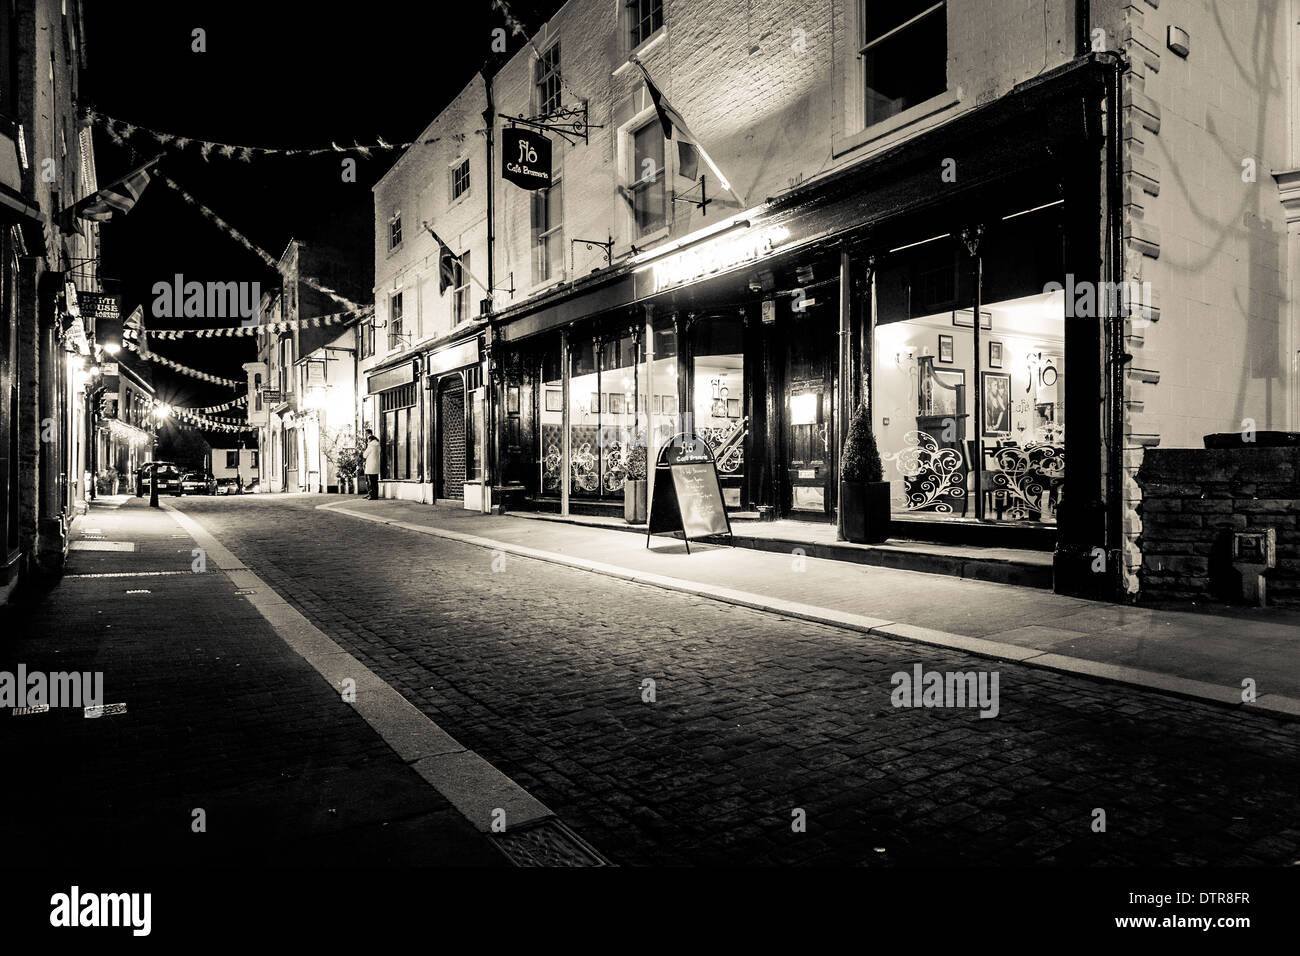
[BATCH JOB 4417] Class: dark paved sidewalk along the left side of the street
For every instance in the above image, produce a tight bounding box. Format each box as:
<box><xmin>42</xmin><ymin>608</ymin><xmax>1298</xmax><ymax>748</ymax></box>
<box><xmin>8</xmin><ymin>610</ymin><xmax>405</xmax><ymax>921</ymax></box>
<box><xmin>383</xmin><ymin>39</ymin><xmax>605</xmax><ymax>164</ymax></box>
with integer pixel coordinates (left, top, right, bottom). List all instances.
<box><xmin>0</xmin><ymin>496</ymin><xmax>508</xmax><ymax>866</ymax></box>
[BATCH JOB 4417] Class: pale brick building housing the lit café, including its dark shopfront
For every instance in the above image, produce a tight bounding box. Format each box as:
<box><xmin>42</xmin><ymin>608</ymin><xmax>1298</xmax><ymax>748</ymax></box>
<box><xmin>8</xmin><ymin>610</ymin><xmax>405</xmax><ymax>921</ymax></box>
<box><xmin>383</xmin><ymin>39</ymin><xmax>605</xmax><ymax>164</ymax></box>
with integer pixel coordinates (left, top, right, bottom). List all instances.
<box><xmin>367</xmin><ymin>0</ymin><xmax>1300</xmax><ymax>597</ymax></box>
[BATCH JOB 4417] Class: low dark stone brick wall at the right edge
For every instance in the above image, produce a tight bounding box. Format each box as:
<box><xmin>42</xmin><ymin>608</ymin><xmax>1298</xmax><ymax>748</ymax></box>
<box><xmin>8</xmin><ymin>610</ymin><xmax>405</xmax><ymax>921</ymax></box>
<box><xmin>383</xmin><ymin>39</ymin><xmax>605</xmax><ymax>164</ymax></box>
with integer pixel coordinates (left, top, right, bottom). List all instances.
<box><xmin>1138</xmin><ymin>447</ymin><xmax>1300</xmax><ymax>606</ymax></box>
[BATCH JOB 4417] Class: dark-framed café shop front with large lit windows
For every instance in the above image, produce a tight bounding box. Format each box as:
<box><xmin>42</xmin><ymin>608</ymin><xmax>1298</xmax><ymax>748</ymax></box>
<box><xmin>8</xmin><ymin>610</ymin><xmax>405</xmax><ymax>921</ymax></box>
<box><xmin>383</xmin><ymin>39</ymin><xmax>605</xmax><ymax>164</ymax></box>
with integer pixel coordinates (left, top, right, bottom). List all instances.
<box><xmin>494</xmin><ymin>57</ymin><xmax>1122</xmax><ymax>590</ymax></box>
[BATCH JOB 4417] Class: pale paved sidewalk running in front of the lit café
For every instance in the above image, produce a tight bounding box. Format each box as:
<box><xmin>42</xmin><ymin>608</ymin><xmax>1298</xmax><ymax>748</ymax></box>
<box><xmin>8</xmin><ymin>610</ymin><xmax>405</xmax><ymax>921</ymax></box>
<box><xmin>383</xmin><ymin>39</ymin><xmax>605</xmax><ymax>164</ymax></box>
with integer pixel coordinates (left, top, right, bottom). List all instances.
<box><xmin>321</xmin><ymin>497</ymin><xmax>1300</xmax><ymax>715</ymax></box>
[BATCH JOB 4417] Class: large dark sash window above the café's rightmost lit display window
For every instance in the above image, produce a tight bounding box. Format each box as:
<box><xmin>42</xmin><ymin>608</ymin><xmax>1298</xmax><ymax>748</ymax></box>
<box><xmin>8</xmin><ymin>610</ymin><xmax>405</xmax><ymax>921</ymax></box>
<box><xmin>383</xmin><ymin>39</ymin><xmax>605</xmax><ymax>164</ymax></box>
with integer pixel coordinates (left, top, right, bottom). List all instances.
<box><xmin>858</xmin><ymin>0</ymin><xmax>948</xmax><ymax>126</ymax></box>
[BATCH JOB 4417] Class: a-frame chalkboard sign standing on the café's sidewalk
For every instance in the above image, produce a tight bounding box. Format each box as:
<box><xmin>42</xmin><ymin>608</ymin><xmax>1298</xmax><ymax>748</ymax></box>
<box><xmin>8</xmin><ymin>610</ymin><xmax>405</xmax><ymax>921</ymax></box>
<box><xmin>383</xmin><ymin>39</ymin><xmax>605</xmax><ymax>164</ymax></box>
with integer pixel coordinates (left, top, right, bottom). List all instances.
<box><xmin>646</xmin><ymin>432</ymin><xmax>732</xmax><ymax>554</ymax></box>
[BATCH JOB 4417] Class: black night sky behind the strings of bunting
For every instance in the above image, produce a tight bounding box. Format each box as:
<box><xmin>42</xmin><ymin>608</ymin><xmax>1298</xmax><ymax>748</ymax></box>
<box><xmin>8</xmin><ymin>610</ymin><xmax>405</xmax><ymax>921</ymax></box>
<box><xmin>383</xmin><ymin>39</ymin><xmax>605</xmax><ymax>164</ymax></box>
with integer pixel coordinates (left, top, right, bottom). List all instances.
<box><xmin>82</xmin><ymin>0</ymin><xmax>560</xmax><ymax>426</ymax></box>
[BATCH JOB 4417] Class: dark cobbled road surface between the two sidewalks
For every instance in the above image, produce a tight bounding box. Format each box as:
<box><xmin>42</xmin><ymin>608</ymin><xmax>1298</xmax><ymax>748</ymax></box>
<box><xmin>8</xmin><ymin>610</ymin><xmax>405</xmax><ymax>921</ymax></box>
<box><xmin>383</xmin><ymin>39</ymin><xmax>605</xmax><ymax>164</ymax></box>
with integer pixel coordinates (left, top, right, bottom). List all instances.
<box><xmin>177</xmin><ymin>496</ymin><xmax>1300</xmax><ymax>866</ymax></box>
